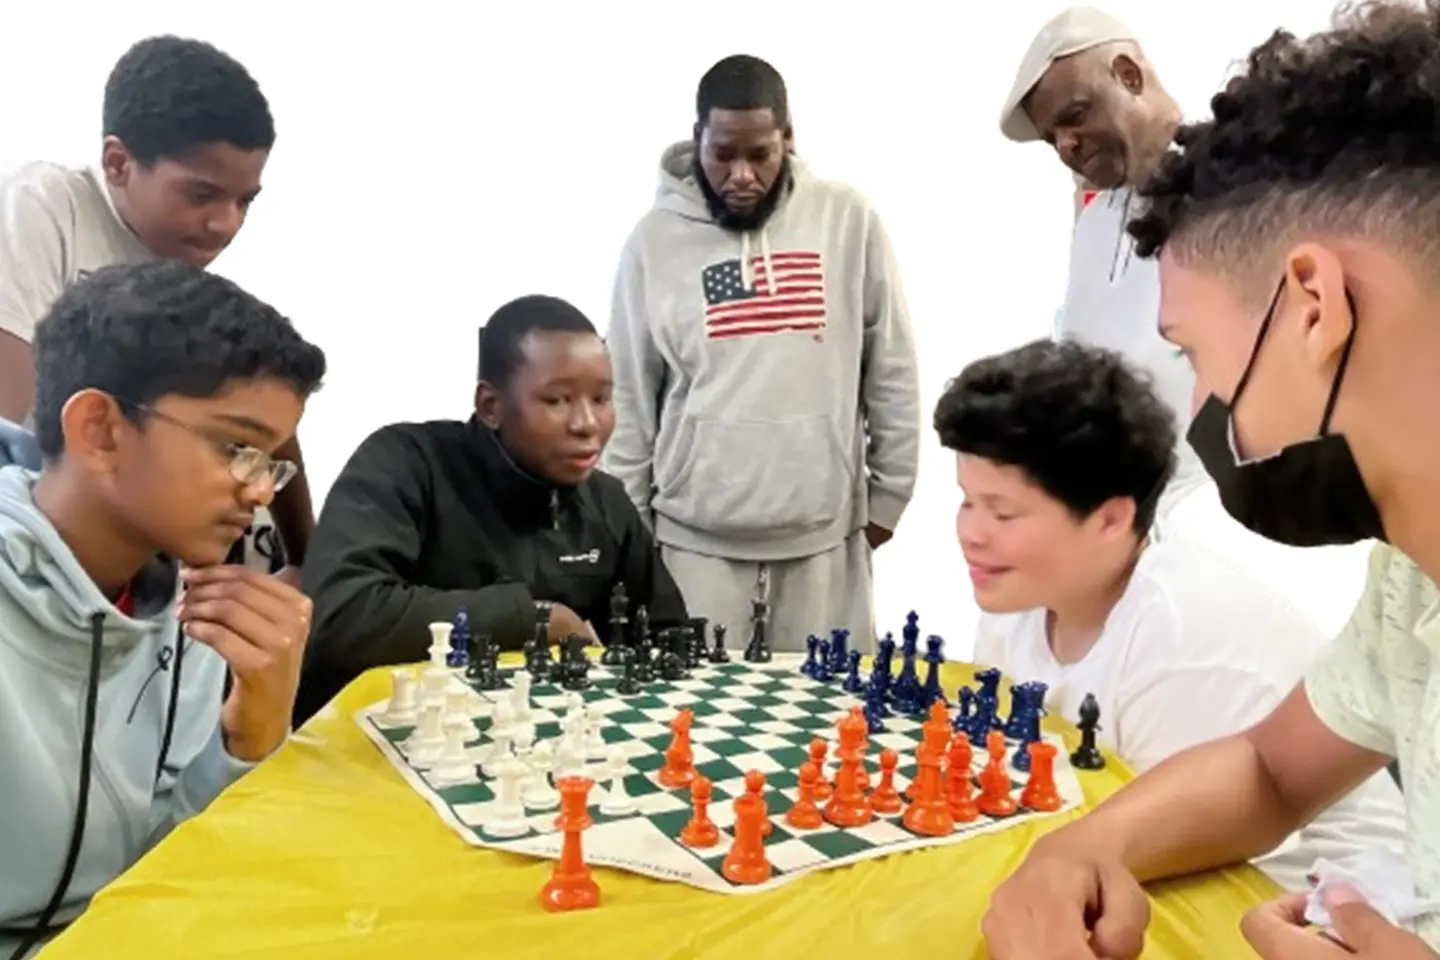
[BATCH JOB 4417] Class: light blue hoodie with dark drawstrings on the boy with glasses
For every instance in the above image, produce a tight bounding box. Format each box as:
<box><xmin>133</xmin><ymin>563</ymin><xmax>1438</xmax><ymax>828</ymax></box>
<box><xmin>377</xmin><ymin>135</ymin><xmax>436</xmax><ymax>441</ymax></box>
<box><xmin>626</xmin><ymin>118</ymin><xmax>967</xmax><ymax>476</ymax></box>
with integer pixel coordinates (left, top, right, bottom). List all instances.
<box><xmin>0</xmin><ymin>460</ymin><xmax>252</xmax><ymax>960</ymax></box>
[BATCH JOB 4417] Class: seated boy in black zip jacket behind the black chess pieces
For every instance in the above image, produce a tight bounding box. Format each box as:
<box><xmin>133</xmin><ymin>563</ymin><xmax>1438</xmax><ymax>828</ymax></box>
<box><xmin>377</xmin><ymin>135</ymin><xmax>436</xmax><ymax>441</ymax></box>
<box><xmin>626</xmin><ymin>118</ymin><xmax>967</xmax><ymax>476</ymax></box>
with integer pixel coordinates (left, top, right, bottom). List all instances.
<box><xmin>295</xmin><ymin>296</ymin><xmax>687</xmax><ymax>724</ymax></box>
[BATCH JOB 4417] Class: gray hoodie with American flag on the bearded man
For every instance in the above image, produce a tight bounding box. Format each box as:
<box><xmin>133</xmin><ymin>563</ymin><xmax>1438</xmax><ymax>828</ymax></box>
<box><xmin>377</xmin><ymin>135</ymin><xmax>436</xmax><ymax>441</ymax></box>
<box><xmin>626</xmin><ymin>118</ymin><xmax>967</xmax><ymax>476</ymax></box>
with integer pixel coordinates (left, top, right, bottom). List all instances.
<box><xmin>605</xmin><ymin>141</ymin><xmax>920</xmax><ymax>560</ymax></box>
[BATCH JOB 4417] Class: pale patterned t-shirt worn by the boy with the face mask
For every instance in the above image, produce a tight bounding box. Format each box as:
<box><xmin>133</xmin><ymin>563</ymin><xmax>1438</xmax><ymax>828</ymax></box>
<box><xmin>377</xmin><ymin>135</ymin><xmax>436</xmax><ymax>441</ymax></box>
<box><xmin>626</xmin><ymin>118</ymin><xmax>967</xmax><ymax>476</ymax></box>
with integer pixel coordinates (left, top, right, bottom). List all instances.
<box><xmin>1305</xmin><ymin>545</ymin><xmax>1440</xmax><ymax>948</ymax></box>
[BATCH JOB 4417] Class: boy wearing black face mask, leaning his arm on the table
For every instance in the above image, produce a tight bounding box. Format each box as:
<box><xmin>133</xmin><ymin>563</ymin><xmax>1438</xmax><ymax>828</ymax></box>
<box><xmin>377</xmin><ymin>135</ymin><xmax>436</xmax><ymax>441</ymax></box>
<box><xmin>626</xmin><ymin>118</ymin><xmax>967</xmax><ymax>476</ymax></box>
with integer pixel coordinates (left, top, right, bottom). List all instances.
<box><xmin>985</xmin><ymin>0</ymin><xmax>1440</xmax><ymax>960</ymax></box>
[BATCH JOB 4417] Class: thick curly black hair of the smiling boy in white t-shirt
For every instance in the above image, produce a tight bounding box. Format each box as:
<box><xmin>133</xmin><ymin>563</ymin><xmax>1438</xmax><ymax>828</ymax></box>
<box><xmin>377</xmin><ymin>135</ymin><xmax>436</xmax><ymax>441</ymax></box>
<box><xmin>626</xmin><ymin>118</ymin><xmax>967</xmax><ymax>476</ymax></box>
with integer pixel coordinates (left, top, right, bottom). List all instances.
<box><xmin>935</xmin><ymin>340</ymin><xmax>1176</xmax><ymax>533</ymax></box>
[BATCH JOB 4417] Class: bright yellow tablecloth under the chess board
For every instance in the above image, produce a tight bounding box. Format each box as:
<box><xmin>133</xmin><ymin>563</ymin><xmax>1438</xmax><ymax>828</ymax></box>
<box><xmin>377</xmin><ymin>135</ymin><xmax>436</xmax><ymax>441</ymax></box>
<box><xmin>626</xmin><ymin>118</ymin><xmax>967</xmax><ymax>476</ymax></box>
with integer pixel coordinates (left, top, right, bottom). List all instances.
<box><xmin>40</xmin><ymin>665</ymin><xmax>1276</xmax><ymax>960</ymax></box>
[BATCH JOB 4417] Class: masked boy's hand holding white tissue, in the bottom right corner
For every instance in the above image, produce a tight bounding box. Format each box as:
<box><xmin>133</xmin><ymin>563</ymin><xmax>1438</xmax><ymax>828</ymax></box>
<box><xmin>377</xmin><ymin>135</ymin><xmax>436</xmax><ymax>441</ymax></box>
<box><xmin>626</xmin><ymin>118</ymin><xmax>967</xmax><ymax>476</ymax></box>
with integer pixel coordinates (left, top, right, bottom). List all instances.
<box><xmin>1240</xmin><ymin>887</ymin><xmax>1440</xmax><ymax>960</ymax></box>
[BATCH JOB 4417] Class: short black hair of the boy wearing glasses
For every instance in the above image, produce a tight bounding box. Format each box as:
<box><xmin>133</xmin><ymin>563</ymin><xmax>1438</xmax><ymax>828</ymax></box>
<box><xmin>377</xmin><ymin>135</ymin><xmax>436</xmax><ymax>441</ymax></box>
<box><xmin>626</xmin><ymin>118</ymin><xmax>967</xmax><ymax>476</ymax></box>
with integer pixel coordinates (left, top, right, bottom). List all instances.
<box><xmin>33</xmin><ymin>261</ymin><xmax>325</xmax><ymax>459</ymax></box>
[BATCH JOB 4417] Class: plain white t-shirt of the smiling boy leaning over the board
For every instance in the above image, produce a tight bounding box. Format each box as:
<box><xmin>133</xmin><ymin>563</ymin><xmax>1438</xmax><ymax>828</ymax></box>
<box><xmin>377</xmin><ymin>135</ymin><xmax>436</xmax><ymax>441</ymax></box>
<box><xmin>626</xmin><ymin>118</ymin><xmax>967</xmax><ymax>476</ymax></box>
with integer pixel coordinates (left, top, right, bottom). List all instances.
<box><xmin>975</xmin><ymin>533</ymin><xmax>1404</xmax><ymax>889</ymax></box>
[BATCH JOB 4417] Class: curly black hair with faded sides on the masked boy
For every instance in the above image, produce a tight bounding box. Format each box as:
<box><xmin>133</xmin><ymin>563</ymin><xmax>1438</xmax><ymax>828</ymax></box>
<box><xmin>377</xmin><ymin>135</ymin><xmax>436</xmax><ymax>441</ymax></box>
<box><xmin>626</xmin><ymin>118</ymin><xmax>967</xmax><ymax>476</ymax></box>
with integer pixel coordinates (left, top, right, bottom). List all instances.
<box><xmin>1129</xmin><ymin>0</ymin><xmax>1440</xmax><ymax>285</ymax></box>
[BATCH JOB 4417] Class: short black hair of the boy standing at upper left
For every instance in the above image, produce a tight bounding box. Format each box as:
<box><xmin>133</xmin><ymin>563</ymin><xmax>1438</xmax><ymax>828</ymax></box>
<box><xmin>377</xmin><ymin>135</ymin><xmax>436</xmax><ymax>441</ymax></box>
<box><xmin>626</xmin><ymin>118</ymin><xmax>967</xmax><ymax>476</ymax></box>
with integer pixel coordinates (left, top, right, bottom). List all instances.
<box><xmin>104</xmin><ymin>36</ymin><xmax>275</xmax><ymax>167</ymax></box>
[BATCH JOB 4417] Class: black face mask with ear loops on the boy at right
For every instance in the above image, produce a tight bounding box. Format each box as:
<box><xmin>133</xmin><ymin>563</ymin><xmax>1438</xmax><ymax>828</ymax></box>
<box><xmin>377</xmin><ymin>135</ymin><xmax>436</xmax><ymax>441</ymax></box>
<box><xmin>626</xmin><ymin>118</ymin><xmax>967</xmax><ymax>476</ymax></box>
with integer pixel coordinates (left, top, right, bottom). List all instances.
<box><xmin>1188</xmin><ymin>282</ymin><xmax>1385</xmax><ymax>547</ymax></box>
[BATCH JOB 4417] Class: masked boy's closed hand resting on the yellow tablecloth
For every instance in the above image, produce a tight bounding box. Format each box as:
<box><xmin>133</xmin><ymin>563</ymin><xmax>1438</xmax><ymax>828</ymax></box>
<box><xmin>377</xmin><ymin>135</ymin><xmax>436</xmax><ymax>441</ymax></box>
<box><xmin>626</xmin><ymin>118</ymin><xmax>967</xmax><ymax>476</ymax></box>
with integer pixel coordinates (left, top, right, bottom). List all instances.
<box><xmin>981</xmin><ymin>841</ymin><xmax>1151</xmax><ymax>960</ymax></box>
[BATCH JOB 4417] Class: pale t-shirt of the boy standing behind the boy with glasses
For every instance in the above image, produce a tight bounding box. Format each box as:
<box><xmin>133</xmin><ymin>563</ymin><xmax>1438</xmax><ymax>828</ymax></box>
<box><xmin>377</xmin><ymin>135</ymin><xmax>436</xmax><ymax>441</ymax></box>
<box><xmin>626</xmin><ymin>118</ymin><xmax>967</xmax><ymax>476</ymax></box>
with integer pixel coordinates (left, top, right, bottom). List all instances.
<box><xmin>0</xmin><ymin>163</ymin><xmax>153</xmax><ymax>343</ymax></box>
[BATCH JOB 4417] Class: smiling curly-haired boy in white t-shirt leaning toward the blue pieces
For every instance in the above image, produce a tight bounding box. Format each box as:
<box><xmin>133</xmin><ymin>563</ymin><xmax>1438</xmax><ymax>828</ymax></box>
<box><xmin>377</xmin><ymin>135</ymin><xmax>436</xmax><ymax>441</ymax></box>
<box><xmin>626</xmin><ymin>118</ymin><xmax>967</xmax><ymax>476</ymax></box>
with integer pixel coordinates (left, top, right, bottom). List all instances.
<box><xmin>935</xmin><ymin>341</ymin><xmax>1404</xmax><ymax>889</ymax></box>
